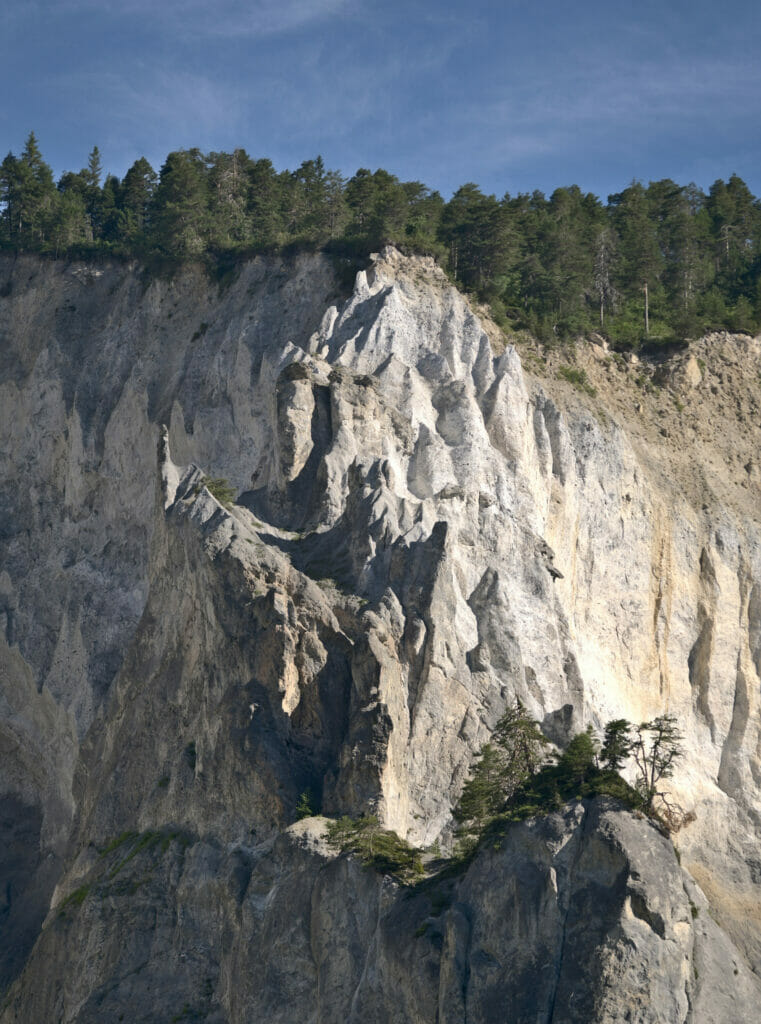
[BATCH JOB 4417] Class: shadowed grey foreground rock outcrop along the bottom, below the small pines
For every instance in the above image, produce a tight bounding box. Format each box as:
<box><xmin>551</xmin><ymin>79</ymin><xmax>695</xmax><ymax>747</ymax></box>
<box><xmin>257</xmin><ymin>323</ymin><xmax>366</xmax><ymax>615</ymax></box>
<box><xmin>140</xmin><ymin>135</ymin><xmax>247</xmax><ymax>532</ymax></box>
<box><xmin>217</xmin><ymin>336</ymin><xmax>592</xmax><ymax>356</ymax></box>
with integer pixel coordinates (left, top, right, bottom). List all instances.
<box><xmin>3</xmin><ymin>800</ymin><xmax>758</xmax><ymax>1024</ymax></box>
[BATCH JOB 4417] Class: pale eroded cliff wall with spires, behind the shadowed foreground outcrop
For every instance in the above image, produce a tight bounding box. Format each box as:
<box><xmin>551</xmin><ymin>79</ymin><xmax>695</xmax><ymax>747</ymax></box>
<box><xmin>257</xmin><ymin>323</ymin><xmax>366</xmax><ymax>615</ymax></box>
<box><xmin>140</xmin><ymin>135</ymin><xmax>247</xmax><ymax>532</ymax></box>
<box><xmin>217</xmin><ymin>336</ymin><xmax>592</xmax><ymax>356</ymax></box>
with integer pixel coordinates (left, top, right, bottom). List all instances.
<box><xmin>0</xmin><ymin>250</ymin><xmax>761</xmax><ymax>1021</ymax></box>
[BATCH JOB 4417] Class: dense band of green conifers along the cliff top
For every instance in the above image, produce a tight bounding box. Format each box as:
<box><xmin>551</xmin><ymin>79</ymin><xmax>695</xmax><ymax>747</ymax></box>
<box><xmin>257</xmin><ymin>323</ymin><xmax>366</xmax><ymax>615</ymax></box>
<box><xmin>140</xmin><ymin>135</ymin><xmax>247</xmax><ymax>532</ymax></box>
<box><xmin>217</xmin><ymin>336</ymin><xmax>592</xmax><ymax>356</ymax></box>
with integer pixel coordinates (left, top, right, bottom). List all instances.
<box><xmin>0</xmin><ymin>134</ymin><xmax>761</xmax><ymax>347</ymax></box>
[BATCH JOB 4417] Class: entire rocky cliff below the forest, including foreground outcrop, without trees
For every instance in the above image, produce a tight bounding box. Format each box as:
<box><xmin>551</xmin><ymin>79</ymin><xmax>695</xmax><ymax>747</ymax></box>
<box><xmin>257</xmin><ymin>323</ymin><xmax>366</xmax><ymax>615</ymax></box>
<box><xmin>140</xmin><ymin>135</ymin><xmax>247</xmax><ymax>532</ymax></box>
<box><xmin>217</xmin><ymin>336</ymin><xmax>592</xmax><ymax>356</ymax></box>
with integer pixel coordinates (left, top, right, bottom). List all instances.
<box><xmin>0</xmin><ymin>245</ymin><xmax>761</xmax><ymax>1024</ymax></box>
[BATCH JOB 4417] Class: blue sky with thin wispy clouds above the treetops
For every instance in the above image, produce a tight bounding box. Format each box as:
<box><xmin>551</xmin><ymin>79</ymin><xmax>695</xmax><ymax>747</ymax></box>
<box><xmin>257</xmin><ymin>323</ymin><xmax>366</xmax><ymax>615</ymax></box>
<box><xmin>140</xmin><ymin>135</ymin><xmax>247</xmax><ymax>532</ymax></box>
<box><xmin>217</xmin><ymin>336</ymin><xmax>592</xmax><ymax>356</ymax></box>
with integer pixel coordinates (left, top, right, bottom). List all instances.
<box><xmin>0</xmin><ymin>0</ymin><xmax>761</xmax><ymax>199</ymax></box>
